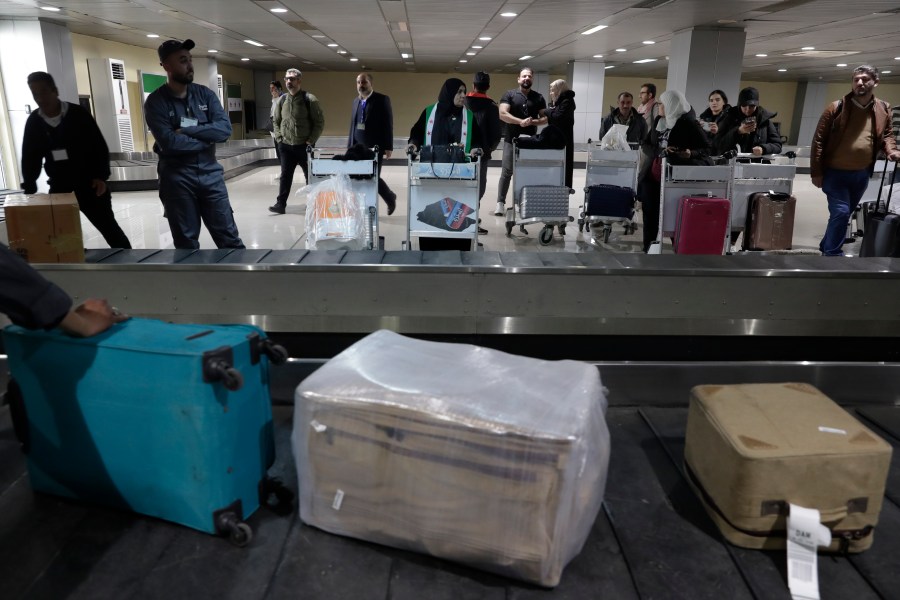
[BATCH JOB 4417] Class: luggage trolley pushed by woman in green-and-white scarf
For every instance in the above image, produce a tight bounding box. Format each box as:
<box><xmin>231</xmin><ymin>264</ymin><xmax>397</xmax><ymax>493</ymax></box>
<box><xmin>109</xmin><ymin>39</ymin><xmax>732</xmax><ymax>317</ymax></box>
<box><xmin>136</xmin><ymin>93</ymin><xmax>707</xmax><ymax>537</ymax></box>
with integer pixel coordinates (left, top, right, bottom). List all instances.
<box><xmin>403</xmin><ymin>150</ymin><xmax>481</xmax><ymax>250</ymax></box>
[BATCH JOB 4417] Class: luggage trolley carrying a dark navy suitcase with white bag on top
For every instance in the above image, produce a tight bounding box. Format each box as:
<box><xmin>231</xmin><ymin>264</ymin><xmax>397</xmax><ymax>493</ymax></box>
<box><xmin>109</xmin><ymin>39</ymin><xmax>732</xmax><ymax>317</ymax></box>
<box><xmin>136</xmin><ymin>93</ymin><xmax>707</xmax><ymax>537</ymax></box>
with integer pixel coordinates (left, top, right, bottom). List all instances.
<box><xmin>578</xmin><ymin>145</ymin><xmax>641</xmax><ymax>242</ymax></box>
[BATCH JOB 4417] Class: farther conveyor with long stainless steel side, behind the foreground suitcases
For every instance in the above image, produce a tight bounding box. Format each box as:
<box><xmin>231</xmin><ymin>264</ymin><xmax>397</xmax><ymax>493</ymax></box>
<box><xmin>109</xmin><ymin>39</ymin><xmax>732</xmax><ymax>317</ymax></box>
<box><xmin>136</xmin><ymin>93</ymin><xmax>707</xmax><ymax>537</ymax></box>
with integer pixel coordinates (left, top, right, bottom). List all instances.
<box><xmin>15</xmin><ymin>249</ymin><xmax>900</xmax><ymax>361</ymax></box>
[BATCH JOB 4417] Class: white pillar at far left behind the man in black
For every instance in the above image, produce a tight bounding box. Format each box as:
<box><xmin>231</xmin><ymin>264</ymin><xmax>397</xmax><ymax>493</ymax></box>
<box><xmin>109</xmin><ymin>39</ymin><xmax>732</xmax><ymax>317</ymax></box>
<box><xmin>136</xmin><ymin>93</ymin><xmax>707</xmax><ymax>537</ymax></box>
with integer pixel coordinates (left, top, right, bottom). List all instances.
<box><xmin>0</xmin><ymin>19</ymin><xmax>78</xmax><ymax>192</ymax></box>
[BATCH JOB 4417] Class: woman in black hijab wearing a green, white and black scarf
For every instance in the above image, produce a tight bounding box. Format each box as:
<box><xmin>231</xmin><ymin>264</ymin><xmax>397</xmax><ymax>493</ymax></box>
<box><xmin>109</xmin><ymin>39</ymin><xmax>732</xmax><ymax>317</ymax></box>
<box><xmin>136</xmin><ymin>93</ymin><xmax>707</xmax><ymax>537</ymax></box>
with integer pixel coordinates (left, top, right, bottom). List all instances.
<box><xmin>407</xmin><ymin>77</ymin><xmax>482</xmax><ymax>250</ymax></box>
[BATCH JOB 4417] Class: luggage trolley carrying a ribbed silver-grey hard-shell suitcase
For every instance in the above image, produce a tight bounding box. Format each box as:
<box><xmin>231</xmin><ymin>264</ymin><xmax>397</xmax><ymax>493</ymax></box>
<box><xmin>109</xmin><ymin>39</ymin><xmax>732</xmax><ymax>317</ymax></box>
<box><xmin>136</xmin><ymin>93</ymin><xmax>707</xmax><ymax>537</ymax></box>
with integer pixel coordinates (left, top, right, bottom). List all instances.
<box><xmin>506</xmin><ymin>140</ymin><xmax>575</xmax><ymax>246</ymax></box>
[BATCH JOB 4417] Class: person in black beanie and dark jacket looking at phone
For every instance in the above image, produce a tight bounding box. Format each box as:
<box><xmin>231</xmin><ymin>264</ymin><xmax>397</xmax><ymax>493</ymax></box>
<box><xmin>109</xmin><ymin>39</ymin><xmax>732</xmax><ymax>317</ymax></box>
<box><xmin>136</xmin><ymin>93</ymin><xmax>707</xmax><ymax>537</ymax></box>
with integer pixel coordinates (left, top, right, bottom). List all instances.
<box><xmin>713</xmin><ymin>87</ymin><xmax>781</xmax><ymax>156</ymax></box>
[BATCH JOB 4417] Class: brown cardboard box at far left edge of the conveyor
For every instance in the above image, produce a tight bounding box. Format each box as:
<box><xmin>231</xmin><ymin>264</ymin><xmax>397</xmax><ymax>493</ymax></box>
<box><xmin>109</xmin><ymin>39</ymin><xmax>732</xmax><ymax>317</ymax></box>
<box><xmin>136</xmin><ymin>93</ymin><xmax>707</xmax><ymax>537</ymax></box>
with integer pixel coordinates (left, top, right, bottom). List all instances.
<box><xmin>4</xmin><ymin>194</ymin><xmax>84</xmax><ymax>263</ymax></box>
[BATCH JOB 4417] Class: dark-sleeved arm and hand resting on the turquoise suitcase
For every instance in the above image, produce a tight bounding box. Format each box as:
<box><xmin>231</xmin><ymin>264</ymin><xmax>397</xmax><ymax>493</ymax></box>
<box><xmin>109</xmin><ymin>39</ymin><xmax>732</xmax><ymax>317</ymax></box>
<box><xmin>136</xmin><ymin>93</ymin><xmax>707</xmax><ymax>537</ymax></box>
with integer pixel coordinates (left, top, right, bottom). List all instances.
<box><xmin>0</xmin><ymin>244</ymin><xmax>128</xmax><ymax>337</ymax></box>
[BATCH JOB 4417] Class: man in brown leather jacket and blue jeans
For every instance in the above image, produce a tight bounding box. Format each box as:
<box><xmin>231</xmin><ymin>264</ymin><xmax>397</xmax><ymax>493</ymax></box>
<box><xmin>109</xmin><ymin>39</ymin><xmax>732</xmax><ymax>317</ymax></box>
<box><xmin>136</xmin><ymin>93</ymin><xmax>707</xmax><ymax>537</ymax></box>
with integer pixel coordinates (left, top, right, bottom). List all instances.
<box><xmin>810</xmin><ymin>65</ymin><xmax>900</xmax><ymax>256</ymax></box>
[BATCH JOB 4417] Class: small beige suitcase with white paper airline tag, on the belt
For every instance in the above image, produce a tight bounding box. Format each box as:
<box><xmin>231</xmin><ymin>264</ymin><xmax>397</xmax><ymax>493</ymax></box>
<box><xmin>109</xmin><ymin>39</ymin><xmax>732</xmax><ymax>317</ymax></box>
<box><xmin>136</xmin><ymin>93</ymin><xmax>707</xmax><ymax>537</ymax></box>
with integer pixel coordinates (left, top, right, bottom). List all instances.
<box><xmin>684</xmin><ymin>383</ymin><xmax>891</xmax><ymax>552</ymax></box>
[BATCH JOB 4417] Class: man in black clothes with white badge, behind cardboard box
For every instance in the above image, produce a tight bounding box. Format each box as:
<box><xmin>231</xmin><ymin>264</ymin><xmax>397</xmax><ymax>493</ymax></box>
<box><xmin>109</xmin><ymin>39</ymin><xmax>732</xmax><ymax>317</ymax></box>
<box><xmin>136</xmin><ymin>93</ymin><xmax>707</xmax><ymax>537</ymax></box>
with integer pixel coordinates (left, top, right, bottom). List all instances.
<box><xmin>22</xmin><ymin>71</ymin><xmax>131</xmax><ymax>248</ymax></box>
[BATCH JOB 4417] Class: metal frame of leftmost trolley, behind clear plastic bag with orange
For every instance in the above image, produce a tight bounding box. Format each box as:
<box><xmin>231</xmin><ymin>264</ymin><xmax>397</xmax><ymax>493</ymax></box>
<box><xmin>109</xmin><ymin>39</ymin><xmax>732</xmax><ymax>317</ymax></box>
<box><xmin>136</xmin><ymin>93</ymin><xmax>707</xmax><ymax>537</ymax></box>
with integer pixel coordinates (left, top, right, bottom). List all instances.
<box><xmin>307</xmin><ymin>146</ymin><xmax>384</xmax><ymax>250</ymax></box>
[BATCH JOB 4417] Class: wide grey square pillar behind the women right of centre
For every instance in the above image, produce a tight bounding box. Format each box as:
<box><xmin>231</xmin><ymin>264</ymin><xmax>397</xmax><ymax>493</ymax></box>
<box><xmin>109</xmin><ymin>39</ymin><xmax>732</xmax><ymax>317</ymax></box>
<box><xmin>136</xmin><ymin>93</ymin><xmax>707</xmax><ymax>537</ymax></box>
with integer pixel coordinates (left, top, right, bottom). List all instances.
<box><xmin>657</xmin><ymin>27</ymin><xmax>747</xmax><ymax>116</ymax></box>
